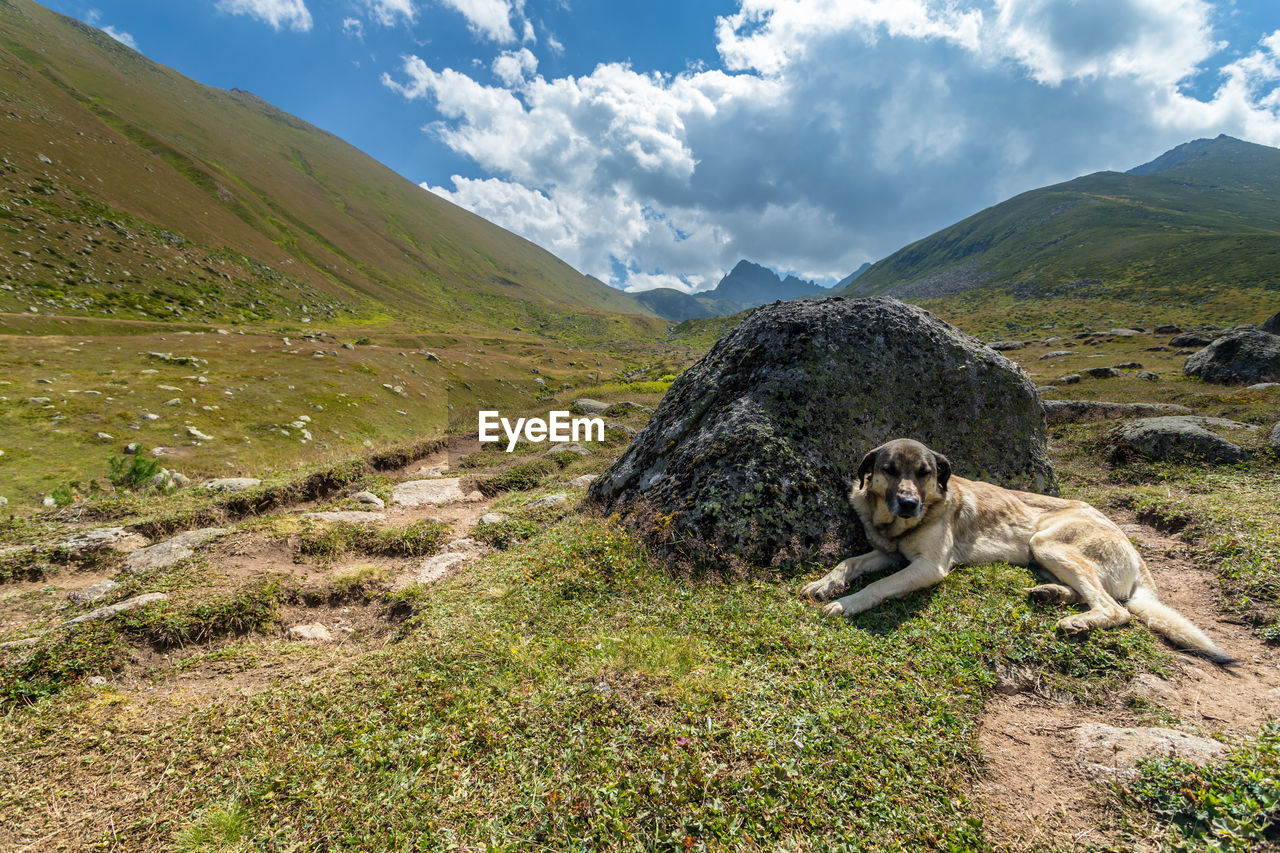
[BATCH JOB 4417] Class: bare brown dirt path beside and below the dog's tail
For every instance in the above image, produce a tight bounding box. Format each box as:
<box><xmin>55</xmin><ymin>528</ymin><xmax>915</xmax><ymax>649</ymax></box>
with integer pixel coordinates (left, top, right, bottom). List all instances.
<box><xmin>974</xmin><ymin>515</ymin><xmax>1280</xmax><ymax>850</ymax></box>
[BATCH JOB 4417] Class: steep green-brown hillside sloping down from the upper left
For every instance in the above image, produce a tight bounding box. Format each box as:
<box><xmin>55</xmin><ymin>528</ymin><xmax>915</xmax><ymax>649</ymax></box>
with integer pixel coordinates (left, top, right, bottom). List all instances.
<box><xmin>0</xmin><ymin>0</ymin><xmax>657</xmax><ymax>336</ymax></box>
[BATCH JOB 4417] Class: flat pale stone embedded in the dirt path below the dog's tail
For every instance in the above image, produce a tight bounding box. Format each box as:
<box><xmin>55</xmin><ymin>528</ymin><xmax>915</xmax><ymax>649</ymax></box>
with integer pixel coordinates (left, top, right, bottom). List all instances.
<box><xmin>1075</xmin><ymin>722</ymin><xmax>1226</xmax><ymax>781</ymax></box>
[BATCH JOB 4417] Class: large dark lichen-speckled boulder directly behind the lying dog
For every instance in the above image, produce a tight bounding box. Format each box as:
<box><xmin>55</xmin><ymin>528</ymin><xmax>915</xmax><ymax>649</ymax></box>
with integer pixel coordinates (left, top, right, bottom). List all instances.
<box><xmin>590</xmin><ymin>297</ymin><xmax>1057</xmax><ymax>566</ymax></box>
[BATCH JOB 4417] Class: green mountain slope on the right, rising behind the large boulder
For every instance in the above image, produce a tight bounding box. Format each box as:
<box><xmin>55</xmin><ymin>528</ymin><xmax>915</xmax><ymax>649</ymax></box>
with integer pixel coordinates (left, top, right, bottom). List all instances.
<box><xmin>840</xmin><ymin>136</ymin><xmax>1280</xmax><ymax>307</ymax></box>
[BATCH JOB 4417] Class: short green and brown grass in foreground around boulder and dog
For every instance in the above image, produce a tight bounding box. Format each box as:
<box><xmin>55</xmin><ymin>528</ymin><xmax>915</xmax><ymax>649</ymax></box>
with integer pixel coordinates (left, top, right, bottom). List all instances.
<box><xmin>0</xmin><ymin>315</ymin><xmax>1280</xmax><ymax>850</ymax></box>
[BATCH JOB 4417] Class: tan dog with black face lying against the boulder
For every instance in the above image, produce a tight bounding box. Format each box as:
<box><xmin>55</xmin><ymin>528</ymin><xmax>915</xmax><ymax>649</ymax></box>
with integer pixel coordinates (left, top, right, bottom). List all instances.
<box><xmin>800</xmin><ymin>438</ymin><xmax>1234</xmax><ymax>666</ymax></box>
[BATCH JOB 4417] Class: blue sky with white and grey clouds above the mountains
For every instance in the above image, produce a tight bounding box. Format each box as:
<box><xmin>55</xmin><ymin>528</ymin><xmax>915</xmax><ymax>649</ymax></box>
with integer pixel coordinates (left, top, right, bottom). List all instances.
<box><xmin>35</xmin><ymin>0</ymin><xmax>1280</xmax><ymax>291</ymax></box>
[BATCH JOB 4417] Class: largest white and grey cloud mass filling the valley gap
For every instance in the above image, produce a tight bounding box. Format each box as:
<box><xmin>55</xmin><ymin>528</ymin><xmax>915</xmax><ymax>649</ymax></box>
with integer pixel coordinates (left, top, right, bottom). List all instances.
<box><xmin>384</xmin><ymin>0</ymin><xmax>1280</xmax><ymax>289</ymax></box>
